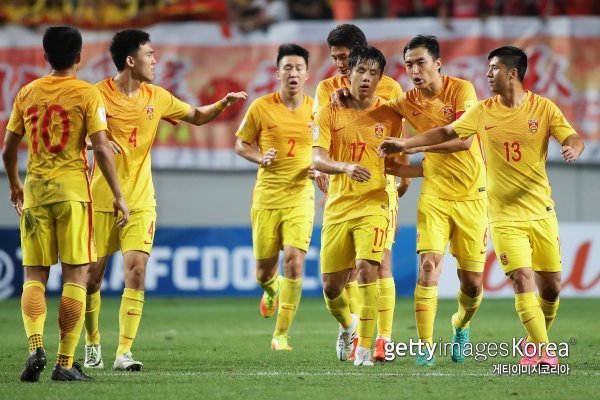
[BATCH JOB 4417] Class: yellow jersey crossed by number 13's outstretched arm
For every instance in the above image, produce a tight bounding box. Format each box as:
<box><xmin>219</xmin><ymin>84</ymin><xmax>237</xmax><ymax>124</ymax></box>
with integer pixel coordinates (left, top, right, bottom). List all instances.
<box><xmin>389</xmin><ymin>76</ymin><xmax>487</xmax><ymax>200</ymax></box>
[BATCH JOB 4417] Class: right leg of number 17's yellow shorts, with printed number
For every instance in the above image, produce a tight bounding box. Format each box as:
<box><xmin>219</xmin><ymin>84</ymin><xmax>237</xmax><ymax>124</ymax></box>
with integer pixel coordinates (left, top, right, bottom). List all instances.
<box><xmin>350</xmin><ymin>215</ymin><xmax>388</xmax><ymax>264</ymax></box>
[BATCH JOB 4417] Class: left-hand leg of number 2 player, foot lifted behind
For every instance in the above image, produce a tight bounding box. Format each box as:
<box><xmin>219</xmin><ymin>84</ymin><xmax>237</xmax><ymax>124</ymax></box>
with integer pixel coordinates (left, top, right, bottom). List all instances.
<box><xmin>251</xmin><ymin>208</ymin><xmax>282</xmax><ymax>318</ymax></box>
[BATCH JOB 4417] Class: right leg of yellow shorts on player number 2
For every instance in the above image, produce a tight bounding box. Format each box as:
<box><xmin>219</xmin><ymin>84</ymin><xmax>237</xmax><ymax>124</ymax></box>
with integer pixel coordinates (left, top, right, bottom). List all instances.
<box><xmin>281</xmin><ymin>204</ymin><xmax>315</xmax><ymax>252</ymax></box>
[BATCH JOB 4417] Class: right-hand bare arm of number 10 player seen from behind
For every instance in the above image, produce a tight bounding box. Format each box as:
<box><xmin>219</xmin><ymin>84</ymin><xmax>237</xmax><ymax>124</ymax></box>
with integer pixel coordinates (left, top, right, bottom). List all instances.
<box><xmin>90</xmin><ymin>131</ymin><xmax>129</xmax><ymax>228</ymax></box>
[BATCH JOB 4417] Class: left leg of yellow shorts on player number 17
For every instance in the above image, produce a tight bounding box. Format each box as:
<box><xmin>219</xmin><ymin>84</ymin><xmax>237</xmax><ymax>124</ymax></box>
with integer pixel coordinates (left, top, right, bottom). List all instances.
<box><xmin>321</xmin><ymin>221</ymin><xmax>356</xmax><ymax>274</ymax></box>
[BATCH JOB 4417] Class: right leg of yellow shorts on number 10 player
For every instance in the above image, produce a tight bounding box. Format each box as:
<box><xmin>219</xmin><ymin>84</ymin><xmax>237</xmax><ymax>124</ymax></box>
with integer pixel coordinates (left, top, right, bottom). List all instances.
<box><xmin>52</xmin><ymin>201</ymin><xmax>96</xmax><ymax>266</ymax></box>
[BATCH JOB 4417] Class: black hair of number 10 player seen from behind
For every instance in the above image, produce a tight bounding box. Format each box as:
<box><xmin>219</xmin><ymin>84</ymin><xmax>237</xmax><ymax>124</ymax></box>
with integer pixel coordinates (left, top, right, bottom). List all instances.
<box><xmin>42</xmin><ymin>26</ymin><xmax>83</xmax><ymax>71</ymax></box>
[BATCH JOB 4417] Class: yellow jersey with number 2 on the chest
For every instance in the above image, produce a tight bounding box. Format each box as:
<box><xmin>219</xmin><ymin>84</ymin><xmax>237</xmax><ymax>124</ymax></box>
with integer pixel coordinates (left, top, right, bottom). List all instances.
<box><xmin>236</xmin><ymin>92</ymin><xmax>315</xmax><ymax>209</ymax></box>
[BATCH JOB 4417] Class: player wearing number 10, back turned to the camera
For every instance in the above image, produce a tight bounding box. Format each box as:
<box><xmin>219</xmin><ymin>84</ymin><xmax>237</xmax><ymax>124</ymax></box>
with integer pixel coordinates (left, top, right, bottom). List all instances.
<box><xmin>2</xmin><ymin>27</ymin><xmax>129</xmax><ymax>382</ymax></box>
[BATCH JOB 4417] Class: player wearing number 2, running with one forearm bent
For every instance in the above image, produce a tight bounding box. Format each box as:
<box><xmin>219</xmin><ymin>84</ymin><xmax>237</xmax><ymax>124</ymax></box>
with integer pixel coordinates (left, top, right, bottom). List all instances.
<box><xmin>235</xmin><ymin>44</ymin><xmax>315</xmax><ymax>350</ymax></box>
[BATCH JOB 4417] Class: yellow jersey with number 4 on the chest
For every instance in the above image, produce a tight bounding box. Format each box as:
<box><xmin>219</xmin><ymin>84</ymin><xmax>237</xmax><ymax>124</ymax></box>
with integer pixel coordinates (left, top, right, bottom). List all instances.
<box><xmin>92</xmin><ymin>78</ymin><xmax>191</xmax><ymax>211</ymax></box>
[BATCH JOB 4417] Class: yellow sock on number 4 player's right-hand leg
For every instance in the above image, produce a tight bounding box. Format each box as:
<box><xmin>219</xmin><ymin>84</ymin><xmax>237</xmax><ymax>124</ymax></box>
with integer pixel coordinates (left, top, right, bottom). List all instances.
<box><xmin>117</xmin><ymin>288</ymin><xmax>144</xmax><ymax>357</ymax></box>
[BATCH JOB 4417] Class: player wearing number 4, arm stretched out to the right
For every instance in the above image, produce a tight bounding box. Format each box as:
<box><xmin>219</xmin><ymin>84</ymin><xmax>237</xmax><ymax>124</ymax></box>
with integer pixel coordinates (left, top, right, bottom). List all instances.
<box><xmin>84</xmin><ymin>30</ymin><xmax>247</xmax><ymax>371</ymax></box>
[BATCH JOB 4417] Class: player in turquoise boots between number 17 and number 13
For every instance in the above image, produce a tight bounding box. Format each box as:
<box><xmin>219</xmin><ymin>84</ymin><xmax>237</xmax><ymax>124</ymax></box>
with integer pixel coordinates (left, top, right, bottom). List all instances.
<box><xmin>384</xmin><ymin>35</ymin><xmax>488</xmax><ymax>366</ymax></box>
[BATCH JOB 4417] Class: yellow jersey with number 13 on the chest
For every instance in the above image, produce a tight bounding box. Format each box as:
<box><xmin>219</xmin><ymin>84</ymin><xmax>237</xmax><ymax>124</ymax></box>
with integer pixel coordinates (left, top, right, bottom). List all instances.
<box><xmin>452</xmin><ymin>91</ymin><xmax>575</xmax><ymax>222</ymax></box>
